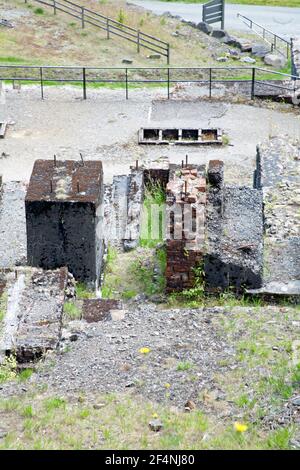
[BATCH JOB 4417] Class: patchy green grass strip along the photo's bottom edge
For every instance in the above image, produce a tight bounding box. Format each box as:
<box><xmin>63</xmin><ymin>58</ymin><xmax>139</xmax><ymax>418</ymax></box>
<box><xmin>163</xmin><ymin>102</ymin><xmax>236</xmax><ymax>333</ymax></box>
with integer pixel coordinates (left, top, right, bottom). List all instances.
<box><xmin>0</xmin><ymin>394</ymin><xmax>295</xmax><ymax>450</ymax></box>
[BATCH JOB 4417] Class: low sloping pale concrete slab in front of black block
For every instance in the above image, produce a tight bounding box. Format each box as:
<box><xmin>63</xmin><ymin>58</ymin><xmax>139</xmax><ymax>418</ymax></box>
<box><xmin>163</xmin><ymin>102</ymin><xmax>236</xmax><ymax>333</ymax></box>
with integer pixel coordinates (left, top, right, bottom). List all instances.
<box><xmin>0</xmin><ymin>268</ymin><xmax>70</xmax><ymax>363</ymax></box>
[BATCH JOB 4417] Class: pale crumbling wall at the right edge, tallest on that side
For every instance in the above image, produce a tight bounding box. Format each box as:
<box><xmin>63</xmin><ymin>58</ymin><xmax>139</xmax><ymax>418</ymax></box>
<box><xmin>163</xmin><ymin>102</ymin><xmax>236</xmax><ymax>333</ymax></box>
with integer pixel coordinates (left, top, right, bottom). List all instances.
<box><xmin>255</xmin><ymin>136</ymin><xmax>300</xmax><ymax>295</ymax></box>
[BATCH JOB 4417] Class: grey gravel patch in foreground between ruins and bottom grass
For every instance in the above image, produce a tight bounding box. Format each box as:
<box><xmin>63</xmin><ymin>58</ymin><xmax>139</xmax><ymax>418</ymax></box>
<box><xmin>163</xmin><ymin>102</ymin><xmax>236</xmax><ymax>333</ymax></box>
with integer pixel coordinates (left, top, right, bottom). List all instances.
<box><xmin>1</xmin><ymin>304</ymin><xmax>233</xmax><ymax>407</ymax></box>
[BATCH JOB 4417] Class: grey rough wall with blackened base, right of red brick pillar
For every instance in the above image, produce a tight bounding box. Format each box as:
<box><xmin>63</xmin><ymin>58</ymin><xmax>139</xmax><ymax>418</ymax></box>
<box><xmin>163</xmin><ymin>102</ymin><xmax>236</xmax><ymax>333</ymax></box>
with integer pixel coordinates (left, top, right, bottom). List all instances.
<box><xmin>205</xmin><ymin>161</ymin><xmax>263</xmax><ymax>292</ymax></box>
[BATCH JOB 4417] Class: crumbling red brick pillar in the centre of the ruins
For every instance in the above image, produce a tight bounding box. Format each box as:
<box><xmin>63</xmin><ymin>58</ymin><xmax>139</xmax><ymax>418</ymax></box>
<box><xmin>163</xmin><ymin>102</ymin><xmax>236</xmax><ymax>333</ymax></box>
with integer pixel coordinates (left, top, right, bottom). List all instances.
<box><xmin>166</xmin><ymin>165</ymin><xmax>206</xmax><ymax>292</ymax></box>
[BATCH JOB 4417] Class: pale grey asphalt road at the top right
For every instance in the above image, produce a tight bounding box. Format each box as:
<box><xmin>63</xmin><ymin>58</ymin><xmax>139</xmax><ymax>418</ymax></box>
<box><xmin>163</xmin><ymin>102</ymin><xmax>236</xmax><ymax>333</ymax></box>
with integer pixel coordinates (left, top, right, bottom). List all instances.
<box><xmin>128</xmin><ymin>0</ymin><xmax>300</xmax><ymax>38</ymax></box>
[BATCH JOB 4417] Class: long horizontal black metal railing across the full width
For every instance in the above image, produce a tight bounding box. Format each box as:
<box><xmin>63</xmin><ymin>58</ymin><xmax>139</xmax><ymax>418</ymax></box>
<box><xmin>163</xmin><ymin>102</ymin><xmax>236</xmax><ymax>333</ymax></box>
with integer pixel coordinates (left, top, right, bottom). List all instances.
<box><xmin>0</xmin><ymin>65</ymin><xmax>300</xmax><ymax>99</ymax></box>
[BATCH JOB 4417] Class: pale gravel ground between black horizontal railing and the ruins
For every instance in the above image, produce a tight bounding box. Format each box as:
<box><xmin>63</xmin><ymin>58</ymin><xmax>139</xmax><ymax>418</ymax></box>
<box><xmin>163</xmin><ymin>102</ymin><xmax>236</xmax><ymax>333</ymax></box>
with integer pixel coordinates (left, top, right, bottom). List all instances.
<box><xmin>0</xmin><ymin>85</ymin><xmax>300</xmax><ymax>185</ymax></box>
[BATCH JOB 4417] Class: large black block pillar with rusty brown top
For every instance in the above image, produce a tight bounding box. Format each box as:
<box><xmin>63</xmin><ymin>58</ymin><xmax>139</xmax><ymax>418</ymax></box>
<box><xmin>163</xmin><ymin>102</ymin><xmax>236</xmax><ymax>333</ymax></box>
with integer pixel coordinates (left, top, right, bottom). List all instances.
<box><xmin>25</xmin><ymin>160</ymin><xmax>103</xmax><ymax>286</ymax></box>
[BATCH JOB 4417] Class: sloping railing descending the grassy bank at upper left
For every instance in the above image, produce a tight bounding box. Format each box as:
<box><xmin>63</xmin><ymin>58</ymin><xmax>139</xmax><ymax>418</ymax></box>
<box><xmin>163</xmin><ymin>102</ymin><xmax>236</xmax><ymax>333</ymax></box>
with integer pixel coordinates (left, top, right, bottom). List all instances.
<box><xmin>25</xmin><ymin>0</ymin><xmax>170</xmax><ymax>64</ymax></box>
